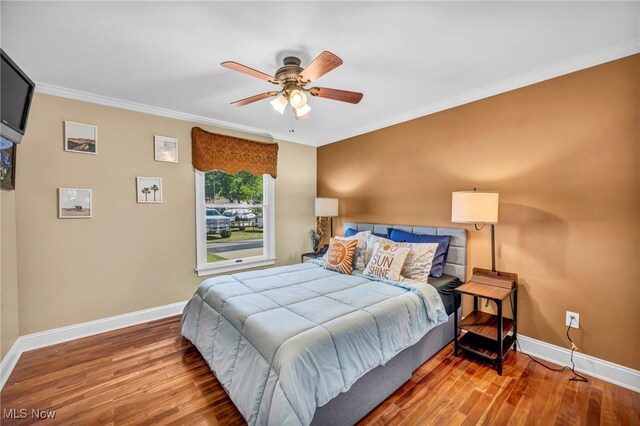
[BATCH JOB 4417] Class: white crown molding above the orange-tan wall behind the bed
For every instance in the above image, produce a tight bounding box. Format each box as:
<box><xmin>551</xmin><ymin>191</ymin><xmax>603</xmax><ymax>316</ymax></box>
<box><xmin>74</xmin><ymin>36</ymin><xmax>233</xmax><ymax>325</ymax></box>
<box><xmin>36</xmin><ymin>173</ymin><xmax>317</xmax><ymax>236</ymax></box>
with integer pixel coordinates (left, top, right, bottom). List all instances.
<box><xmin>318</xmin><ymin>40</ymin><xmax>640</xmax><ymax>146</ymax></box>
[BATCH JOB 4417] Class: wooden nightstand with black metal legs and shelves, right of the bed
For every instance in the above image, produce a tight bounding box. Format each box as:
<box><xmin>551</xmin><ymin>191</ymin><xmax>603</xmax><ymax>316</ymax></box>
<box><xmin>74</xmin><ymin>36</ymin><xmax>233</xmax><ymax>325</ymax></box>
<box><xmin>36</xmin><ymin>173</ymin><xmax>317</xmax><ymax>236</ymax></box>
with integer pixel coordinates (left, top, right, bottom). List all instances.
<box><xmin>453</xmin><ymin>268</ymin><xmax>518</xmax><ymax>375</ymax></box>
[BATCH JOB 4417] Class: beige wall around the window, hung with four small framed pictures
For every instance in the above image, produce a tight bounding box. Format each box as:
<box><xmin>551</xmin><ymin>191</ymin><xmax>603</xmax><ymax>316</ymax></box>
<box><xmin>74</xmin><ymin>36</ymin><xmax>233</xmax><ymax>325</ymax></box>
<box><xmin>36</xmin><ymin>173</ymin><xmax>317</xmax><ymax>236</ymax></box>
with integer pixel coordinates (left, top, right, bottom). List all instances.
<box><xmin>14</xmin><ymin>94</ymin><xmax>316</xmax><ymax>334</ymax></box>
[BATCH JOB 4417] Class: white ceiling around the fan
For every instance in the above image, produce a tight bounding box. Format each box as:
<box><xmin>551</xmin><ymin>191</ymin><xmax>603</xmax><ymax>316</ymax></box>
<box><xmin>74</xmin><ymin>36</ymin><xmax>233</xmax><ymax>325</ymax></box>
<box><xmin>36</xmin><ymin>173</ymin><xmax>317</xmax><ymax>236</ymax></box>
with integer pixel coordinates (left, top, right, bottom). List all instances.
<box><xmin>0</xmin><ymin>1</ymin><xmax>640</xmax><ymax>146</ymax></box>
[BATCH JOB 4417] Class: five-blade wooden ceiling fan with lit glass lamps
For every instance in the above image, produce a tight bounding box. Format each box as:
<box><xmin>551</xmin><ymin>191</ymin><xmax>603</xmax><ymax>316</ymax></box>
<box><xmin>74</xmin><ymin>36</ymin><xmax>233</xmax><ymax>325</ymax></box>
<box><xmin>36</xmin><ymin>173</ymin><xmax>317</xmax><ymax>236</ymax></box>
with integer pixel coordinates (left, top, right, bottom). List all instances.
<box><xmin>220</xmin><ymin>50</ymin><xmax>362</xmax><ymax>120</ymax></box>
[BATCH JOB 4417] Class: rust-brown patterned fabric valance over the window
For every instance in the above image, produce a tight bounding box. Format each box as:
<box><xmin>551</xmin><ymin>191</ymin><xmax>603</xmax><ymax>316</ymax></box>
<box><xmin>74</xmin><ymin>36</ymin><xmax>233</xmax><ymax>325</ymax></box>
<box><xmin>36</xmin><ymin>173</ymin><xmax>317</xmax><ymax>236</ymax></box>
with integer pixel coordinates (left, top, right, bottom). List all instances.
<box><xmin>191</xmin><ymin>127</ymin><xmax>278</xmax><ymax>179</ymax></box>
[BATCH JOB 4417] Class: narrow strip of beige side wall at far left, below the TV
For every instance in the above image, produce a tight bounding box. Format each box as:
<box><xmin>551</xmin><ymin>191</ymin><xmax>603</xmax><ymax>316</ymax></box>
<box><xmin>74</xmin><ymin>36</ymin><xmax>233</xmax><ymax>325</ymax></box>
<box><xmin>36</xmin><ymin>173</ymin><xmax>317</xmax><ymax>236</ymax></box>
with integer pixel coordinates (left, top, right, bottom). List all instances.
<box><xmin>0</xmin><ymin>190</ymin><xmax>19</xmax><ymax>359</ymax></box>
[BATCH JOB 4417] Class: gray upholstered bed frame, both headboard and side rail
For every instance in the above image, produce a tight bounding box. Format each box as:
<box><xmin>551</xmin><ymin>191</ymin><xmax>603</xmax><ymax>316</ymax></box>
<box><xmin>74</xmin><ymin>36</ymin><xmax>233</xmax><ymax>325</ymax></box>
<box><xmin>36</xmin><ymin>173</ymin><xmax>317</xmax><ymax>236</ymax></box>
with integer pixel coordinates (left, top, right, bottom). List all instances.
<box><xmin>311</xmin><ymin>222</ymin><xmax>467</xmax><ymax>426</ymax></box>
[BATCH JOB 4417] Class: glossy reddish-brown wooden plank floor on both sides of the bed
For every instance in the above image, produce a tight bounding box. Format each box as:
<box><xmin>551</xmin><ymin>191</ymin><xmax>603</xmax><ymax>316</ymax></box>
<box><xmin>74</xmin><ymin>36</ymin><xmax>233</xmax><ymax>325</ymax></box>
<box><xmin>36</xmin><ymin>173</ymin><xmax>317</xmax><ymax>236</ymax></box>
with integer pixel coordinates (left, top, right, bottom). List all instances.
<box><xmin>0</xmin><ymin>317</ymin><xmax>640</xmax><ymax>425</ymax></box>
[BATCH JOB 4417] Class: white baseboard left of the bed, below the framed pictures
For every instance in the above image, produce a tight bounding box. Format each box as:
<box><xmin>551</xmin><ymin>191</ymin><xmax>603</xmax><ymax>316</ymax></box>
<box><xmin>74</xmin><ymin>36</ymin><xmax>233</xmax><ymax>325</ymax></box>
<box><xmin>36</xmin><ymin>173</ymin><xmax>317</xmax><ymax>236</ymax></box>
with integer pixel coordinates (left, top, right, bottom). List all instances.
<box><xmin>0</xmin><ymin>301</ymin><xmax>187</xmax><ymax>389</ymax></box>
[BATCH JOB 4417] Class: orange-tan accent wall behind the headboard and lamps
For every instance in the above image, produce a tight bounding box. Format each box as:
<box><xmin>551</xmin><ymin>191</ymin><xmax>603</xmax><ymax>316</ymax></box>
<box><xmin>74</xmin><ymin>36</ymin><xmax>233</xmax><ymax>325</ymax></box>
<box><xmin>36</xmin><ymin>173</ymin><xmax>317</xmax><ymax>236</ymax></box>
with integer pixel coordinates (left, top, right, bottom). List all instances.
<box><xmin>318</xmin><ymin>55</ymin><xmax>640</xmax><ymax>369</ymax></box>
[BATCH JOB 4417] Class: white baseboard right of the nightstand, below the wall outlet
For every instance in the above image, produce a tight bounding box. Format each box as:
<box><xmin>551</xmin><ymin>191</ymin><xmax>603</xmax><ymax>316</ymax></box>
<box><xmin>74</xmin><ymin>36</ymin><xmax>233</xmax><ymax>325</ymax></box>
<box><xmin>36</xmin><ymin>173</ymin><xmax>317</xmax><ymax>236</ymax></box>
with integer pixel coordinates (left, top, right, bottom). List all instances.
<box><xmin>518</xmin><ymin>334</ymin><xmax>640</xmax><ymax>392</ymax></box>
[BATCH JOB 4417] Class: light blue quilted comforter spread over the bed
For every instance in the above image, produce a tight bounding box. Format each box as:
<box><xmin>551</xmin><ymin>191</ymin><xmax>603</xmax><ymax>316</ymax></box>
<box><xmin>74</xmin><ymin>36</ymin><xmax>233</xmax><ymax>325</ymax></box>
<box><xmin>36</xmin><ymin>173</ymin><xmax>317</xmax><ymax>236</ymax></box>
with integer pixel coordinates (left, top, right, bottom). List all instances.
<box><xmin>182</xmin><ymin>261</ymin><xmax>447</xmax><ymax>425</ymax></box>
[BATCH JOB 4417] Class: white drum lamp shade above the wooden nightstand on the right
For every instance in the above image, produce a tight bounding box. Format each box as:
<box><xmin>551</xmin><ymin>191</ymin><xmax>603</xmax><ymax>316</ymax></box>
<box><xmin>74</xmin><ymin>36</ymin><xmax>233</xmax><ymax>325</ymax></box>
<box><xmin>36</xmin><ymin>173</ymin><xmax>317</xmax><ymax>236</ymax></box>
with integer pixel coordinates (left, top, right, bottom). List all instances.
<box><xmin>451</xmin><ymin>191</ymin><xmax>500</xmax><ymax>223</ymax></box>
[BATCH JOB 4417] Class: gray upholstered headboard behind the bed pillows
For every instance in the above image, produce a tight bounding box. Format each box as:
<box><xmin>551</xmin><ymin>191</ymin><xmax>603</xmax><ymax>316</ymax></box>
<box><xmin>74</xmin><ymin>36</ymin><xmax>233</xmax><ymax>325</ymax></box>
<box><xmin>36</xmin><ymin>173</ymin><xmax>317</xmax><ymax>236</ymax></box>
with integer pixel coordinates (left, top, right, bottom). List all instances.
<box><xmin>343</xmin><ymin>222</ymin><xmax>467</xmax><ymax>282</ymax></box>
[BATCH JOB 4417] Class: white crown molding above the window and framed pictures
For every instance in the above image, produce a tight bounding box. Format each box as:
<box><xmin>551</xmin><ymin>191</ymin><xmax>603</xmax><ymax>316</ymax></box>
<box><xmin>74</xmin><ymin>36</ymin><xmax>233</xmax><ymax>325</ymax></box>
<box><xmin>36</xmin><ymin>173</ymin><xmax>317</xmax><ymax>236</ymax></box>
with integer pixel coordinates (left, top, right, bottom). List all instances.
<box><xmin>36</xmin><ymin>82</ymin><xmax>315</xmax><ymax>146</ymax></box>
